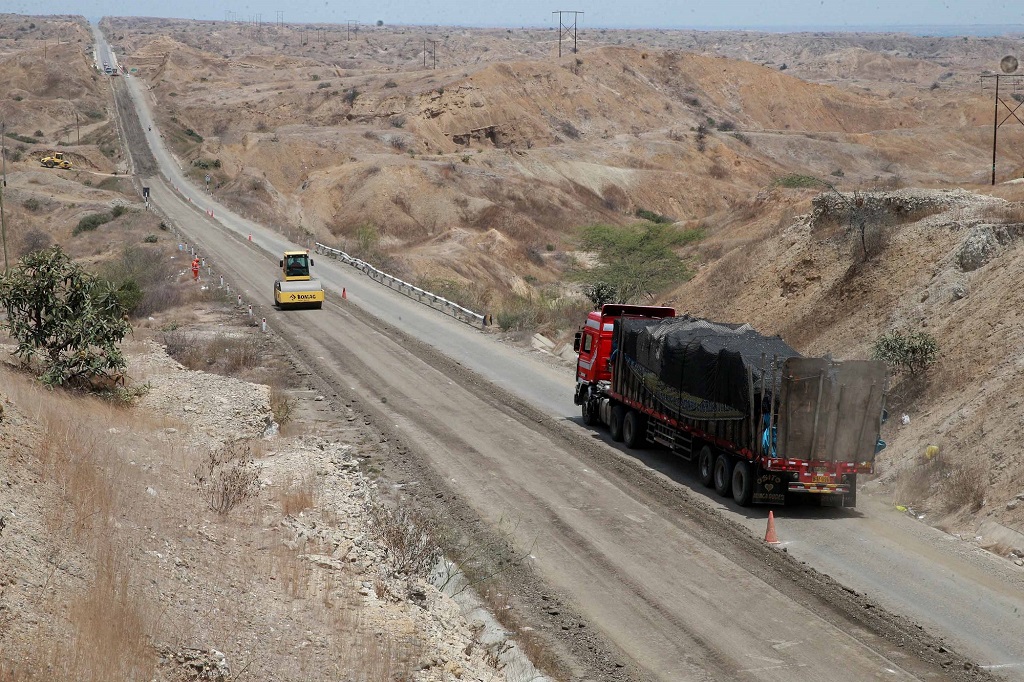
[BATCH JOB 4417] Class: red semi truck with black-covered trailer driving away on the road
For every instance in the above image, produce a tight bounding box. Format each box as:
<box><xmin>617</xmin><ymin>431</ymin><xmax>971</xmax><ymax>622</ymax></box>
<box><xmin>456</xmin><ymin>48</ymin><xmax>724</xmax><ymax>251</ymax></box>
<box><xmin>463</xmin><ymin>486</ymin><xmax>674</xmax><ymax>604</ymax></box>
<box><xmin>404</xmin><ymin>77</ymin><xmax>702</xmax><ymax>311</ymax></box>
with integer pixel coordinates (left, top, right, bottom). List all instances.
<box><xmin>574</xmin><ymin>304</ymin><xmax>888</xmax><ymax>507</ymax></box>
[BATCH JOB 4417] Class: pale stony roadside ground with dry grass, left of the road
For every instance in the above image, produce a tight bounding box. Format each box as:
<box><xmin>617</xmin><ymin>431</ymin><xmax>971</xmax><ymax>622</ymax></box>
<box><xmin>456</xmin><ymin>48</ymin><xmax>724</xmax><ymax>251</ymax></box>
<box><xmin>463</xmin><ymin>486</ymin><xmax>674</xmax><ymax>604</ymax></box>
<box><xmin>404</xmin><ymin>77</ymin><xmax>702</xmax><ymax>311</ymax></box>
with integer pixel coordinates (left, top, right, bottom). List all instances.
<box><xmin>0</xmin><ymin>301</ymin><xmax>520</xmax><ymax>681</ymax></box>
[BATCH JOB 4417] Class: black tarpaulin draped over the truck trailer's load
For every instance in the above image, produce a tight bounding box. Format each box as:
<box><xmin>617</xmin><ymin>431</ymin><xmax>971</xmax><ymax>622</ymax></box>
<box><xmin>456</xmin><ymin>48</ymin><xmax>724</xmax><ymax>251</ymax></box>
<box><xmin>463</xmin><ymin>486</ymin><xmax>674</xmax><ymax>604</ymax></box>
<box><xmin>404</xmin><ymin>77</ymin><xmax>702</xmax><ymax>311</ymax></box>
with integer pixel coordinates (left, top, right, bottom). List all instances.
<box><xmin>614</xmin><ymin>315</ymin><xmax>800</xmax><ymax>419</ymax></box>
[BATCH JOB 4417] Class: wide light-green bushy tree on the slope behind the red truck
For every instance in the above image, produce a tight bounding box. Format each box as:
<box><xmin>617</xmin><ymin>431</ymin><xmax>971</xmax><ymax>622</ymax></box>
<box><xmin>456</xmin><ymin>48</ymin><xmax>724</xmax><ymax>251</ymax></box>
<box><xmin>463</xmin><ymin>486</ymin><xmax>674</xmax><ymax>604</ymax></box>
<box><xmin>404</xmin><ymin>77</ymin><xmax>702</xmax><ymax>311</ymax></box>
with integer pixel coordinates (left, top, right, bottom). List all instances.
<box><xmin>574</xmin><ymin>222</ymin><xmax>703</xmax><ymax>303</ymax></box>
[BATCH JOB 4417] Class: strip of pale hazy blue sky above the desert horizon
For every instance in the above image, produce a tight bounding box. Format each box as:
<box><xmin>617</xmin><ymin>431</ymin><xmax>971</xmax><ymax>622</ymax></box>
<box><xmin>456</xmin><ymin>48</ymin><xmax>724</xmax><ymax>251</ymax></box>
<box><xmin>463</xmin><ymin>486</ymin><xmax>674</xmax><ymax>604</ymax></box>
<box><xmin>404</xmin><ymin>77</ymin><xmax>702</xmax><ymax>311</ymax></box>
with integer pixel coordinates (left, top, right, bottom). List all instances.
<box><xmin>8</xmin><ymin>0</ymin><xmax>1024</xmax><ymax>32</ymax></box>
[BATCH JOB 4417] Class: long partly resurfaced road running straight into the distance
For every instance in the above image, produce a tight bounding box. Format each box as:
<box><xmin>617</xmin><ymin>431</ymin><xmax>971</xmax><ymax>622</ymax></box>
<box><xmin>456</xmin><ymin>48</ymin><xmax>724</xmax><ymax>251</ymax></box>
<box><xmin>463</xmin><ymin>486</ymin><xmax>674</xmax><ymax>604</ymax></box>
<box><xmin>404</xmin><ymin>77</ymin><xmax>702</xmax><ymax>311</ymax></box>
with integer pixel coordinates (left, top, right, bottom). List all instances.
<box><xmin>97</xmin><ymin>22</ymin><xmax>1024</xmax><ymax>680</ymax></box>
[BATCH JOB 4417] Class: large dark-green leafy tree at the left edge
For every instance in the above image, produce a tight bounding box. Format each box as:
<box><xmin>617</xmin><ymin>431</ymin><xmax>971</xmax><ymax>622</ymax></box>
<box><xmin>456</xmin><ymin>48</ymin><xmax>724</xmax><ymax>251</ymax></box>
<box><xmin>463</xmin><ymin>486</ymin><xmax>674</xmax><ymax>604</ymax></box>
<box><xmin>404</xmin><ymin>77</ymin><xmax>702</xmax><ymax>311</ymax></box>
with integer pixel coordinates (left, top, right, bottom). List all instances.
<box><xmin>0</xmin><ymin>246</ymin><xmax>131</xmax><ymax>386</ymax></box>
